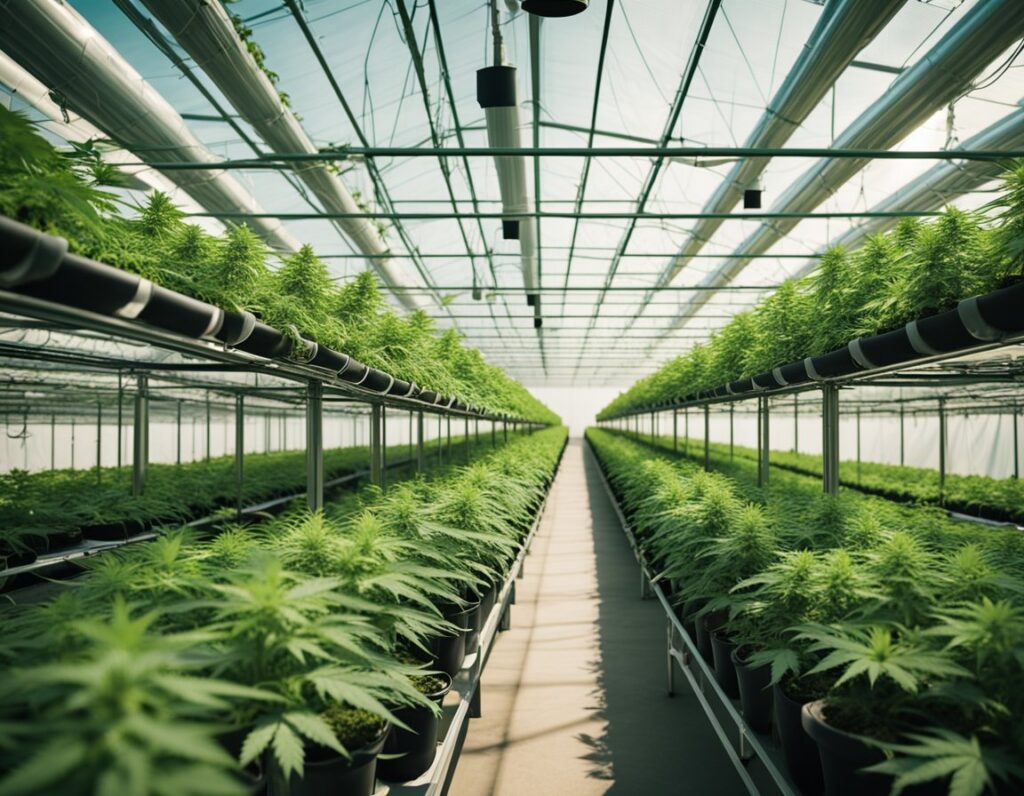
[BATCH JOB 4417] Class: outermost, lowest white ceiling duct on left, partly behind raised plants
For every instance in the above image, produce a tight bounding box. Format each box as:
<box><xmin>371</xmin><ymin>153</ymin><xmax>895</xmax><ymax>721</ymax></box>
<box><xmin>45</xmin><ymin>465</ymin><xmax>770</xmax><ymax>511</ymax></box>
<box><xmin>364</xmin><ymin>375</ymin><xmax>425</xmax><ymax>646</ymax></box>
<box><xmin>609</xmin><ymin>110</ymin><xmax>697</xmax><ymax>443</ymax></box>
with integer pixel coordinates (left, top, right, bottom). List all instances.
<box><xmin>0</xmin><ymin>52</ymin><xmax>223</xmax><ymax>233</ymax></box>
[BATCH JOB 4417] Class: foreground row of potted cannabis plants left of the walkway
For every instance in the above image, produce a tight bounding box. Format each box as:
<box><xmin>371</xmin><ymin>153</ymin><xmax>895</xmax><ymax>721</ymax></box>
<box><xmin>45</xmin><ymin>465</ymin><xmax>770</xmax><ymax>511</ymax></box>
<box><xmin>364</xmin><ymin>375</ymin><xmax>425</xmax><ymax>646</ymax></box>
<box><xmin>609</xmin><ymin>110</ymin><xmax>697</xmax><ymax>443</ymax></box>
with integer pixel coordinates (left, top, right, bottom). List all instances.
<box><xmin>0</xmin><ymin>428</ymin><xmax>565</xmax><ymax>796</ymax></box>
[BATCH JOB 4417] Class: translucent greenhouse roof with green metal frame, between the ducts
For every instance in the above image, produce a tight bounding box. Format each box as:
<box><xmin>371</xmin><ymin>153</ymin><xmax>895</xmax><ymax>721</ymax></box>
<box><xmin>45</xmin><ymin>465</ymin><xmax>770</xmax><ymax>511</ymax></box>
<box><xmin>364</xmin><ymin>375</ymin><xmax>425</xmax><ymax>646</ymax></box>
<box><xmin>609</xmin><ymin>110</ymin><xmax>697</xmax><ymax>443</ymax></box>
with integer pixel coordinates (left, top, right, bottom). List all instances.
<box><xmin>6</xmin><ymin>0</ymin><xmax>1024</xmax><ymax>387</ymax></box>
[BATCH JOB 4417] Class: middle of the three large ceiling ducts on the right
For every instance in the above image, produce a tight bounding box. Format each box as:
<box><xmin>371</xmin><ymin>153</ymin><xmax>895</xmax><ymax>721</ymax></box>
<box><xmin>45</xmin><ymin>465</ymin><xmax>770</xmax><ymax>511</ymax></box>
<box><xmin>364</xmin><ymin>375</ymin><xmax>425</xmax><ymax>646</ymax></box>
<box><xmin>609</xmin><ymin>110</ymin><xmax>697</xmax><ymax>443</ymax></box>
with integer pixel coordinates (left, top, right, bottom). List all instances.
<box><xmin>666</xmin><ymin>0</ymin><xmax>1024</xmax><ymax>338</ymax></box>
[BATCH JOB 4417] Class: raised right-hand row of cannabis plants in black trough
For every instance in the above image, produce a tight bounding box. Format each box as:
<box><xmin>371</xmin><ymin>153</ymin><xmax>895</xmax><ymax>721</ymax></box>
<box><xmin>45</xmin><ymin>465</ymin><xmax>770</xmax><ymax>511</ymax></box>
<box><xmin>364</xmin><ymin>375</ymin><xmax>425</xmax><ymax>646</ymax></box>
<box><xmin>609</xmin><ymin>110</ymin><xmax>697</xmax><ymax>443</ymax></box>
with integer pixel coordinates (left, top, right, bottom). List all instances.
<box><xmin>599</xmin><ymin>164</ymin><xmax>1024</xmax><ymax>419</ymax></box>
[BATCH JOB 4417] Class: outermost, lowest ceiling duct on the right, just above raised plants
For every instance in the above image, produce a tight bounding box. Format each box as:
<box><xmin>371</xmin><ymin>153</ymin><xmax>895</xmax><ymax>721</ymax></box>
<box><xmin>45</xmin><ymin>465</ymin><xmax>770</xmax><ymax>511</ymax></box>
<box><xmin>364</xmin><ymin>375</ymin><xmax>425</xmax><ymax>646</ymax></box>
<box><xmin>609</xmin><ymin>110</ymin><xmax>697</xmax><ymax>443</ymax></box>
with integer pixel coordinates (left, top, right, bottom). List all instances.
<box><xmin>794</xmin><ymin>102</ymin><xmax>1024</xmax><ymax>278</ymax></box>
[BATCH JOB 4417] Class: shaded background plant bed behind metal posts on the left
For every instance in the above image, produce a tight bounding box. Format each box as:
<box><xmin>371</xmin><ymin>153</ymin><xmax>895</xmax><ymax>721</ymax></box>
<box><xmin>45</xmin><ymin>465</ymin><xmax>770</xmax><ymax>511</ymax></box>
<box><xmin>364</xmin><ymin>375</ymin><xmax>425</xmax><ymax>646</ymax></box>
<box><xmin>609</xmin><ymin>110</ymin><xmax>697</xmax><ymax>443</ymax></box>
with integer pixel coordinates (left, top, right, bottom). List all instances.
<box><xmin>0</xmin><ymin>428</ymin><xmax>503</xmax><ymax>571</ymax></box>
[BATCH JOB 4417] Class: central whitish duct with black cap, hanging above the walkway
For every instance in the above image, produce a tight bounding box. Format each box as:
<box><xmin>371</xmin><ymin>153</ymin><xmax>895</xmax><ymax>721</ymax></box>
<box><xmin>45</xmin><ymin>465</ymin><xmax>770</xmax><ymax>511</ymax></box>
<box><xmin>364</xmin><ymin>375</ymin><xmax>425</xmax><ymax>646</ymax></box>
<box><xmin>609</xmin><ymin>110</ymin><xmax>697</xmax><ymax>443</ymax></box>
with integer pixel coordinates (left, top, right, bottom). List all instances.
<box><xmin>476</xmin><ymin>66</ymin><xmax>540</xmax><ymax>306</ymax></box>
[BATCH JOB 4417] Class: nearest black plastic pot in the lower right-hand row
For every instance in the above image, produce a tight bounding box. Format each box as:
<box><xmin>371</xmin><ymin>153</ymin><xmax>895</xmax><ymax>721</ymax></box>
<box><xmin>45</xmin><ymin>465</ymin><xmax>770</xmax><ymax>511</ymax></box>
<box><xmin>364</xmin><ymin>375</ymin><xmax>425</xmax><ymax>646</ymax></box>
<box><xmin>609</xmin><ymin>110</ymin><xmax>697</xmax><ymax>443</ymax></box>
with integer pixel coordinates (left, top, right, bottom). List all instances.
<box><xmin>801</xmin><ymin>700</ymin><xmax>892</xmax><ymax>796</ymax></box>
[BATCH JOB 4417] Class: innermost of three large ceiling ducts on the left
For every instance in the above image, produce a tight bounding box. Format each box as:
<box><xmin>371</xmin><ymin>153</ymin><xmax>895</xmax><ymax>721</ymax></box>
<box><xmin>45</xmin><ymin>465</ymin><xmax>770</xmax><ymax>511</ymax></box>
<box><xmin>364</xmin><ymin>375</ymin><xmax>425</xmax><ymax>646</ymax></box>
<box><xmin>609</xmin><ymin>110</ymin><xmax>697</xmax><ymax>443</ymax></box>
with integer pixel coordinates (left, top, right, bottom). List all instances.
<box><xmin>135</xmin><ymin>0</ymin><xmax>428</xmax><ymax>309</ymax></box>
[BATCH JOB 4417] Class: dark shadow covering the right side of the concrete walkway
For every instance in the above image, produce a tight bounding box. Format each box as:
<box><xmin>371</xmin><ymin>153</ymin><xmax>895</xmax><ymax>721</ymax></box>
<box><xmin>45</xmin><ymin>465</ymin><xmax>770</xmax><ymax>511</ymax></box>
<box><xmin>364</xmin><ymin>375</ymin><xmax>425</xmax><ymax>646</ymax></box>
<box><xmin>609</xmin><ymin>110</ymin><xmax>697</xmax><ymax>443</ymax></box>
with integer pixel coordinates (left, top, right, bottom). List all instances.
<box><xmin>573</xmin><ymin>442</ymin><xmax>746</xmax><ymax>796</ymax></box>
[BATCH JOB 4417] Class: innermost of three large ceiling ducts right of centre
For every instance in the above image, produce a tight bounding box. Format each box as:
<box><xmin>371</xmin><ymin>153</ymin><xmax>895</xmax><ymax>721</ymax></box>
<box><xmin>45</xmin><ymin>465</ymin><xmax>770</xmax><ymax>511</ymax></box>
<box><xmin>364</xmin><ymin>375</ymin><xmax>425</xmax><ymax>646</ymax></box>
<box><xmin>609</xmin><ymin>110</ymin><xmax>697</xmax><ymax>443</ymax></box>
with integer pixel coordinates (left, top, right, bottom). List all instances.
<box><xmin>644</xmin><ymin>0</ymin><xmax>906</xmax><ymax>295</ymax></box>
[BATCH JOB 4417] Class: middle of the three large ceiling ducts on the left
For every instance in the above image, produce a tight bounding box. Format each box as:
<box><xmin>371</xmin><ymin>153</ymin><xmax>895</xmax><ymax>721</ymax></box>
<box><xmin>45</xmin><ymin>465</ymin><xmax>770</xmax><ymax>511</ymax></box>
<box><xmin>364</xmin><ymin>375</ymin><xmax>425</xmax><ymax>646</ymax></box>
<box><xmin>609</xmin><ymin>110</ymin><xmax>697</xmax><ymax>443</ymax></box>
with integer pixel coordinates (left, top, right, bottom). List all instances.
<box><xmin>0</xmin><ymin>0</ymin><xmax>299</xmax><ymax>251</ymax></box>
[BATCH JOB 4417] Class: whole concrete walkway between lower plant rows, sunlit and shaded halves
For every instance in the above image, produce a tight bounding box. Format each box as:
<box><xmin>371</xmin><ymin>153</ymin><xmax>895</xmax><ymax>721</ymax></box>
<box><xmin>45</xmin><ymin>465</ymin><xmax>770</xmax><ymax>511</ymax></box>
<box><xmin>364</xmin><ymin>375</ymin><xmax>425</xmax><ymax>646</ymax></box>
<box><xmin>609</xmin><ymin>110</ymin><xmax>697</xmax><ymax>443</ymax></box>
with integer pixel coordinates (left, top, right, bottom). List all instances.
<box><xmin>449</xmin><ymin>441</ymin><xmax>745</xmax><ymax>796</ymax></box>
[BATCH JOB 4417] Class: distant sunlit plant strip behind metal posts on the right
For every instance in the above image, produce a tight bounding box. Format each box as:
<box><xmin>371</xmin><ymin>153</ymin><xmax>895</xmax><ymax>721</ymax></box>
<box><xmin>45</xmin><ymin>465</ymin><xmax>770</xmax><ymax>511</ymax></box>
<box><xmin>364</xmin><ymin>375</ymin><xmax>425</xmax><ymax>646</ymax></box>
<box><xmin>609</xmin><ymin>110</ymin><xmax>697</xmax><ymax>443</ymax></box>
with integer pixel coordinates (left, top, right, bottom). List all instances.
<box><xmin>634</xmin><ymin>436</ymin><xmax>1024</xmax><ymax>525</ymax></box>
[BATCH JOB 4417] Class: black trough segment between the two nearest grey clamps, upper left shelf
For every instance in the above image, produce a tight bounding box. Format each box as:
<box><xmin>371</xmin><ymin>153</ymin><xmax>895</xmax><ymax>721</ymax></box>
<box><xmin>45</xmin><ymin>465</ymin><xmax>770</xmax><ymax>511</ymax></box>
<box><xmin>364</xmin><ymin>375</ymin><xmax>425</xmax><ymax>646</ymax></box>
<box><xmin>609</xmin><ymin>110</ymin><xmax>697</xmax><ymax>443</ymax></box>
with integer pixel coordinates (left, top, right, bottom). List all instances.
<box><xmin>16</xmin><ymin>254</ymin><xmax>148</xmax><ymax>317</ymax></box>
